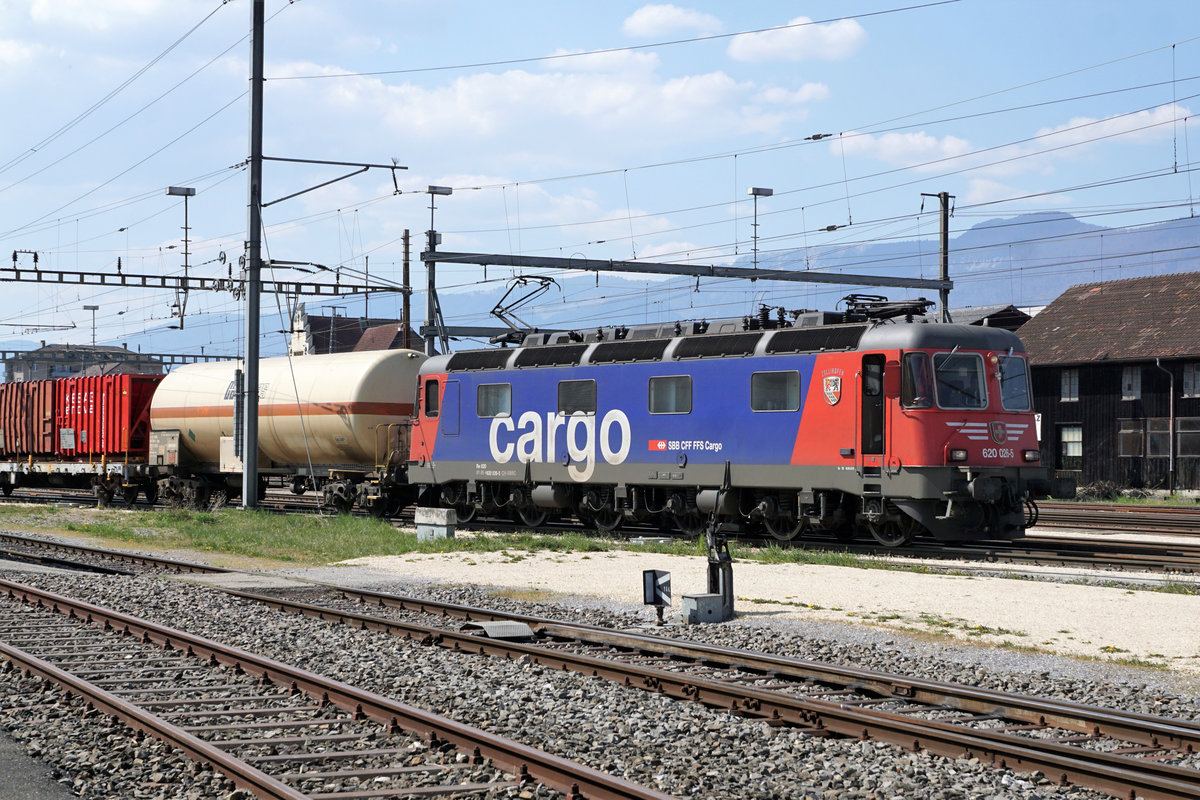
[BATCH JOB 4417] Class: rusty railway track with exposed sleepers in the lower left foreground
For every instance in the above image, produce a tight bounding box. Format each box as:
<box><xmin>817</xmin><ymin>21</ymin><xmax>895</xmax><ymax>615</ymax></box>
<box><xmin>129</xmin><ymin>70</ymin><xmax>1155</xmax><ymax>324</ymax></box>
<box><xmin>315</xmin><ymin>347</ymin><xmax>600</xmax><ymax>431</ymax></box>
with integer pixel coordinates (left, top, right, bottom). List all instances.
<box><xmin>0</xmin><ymin>579</ymin><xmax>670</xmax><ymax>800</ymax></box>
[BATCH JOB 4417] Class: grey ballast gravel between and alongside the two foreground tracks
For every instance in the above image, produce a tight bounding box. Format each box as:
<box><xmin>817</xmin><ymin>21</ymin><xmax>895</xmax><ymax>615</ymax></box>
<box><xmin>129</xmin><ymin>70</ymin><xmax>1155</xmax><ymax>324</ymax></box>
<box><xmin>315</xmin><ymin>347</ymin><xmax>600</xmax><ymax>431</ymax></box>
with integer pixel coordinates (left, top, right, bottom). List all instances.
<box><xmin>7</xmin><ymin>573</ymin><xmax>1200</xmax><ymax>800</ymax></box>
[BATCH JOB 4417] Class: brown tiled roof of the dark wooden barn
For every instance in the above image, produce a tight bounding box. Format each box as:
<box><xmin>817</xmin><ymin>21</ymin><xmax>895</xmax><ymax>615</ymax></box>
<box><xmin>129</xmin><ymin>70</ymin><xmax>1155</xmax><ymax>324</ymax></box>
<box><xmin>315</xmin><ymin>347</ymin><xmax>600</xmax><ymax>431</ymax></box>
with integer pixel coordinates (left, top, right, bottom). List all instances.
<box><xmin>1019</xmin><ymin>272</ymin><xmax>1200</xmax><ymax>365</ymax></box>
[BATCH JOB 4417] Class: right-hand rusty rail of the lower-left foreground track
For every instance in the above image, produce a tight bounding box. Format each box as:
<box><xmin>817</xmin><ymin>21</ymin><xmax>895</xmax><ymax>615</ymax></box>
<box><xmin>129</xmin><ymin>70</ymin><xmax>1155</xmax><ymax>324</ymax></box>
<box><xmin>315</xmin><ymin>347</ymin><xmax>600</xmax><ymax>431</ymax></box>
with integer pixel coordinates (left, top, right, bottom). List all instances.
<box><xmin>0</xmin><ymin>579</ymin><xmax>674</xmax><ymax>800</ymax></box>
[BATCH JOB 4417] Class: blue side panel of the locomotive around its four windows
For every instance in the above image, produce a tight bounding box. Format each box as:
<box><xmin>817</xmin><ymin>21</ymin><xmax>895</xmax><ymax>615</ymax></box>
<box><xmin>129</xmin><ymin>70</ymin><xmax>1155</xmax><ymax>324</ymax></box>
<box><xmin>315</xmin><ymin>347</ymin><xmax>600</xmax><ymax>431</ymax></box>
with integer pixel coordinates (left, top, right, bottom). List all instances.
<box><xmin>417</xmin><ymin>355</ymin><xmax>817</xmax><ymax>472</ymax></box>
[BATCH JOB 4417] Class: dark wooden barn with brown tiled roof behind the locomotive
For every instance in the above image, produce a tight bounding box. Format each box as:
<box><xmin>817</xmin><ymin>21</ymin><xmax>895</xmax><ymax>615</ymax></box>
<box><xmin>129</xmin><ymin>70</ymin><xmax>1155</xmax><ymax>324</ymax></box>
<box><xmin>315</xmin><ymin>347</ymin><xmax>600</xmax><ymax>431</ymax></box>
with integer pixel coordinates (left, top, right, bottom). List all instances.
<box><xmin>1019</xmin><ymin>272</ymin><xmax>1200</xmax><ymax>489</ymax></box>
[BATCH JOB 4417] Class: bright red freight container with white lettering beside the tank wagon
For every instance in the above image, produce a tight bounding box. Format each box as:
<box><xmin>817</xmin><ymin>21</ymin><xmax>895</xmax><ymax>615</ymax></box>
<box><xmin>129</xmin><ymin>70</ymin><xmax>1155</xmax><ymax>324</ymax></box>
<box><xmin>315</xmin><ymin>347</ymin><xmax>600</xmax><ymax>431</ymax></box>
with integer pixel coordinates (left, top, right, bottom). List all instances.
<box><xmin>54</xmin><ymin>375</ymin><xmax>163</xmax><ymax>461</ymax></box>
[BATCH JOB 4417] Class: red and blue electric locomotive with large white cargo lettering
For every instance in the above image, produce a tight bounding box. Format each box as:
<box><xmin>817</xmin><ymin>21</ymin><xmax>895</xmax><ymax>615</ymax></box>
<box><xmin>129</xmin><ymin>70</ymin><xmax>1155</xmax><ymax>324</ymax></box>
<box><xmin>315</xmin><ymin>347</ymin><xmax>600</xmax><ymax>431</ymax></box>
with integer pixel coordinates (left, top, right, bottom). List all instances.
<box><xmin>409</xmin><ymin>324</ymin><xmax>1048</xmax><ymax>542</ymax></box>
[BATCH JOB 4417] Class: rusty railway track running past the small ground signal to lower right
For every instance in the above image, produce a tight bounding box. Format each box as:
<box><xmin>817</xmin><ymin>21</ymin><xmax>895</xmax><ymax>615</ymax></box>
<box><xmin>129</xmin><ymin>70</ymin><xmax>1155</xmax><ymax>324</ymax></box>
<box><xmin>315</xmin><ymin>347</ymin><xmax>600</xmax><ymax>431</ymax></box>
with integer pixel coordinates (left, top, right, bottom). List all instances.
<box><xmin>0</xmin><ymin>527</ymin><xmax>1200</xmax><ymax>799</ymax></box>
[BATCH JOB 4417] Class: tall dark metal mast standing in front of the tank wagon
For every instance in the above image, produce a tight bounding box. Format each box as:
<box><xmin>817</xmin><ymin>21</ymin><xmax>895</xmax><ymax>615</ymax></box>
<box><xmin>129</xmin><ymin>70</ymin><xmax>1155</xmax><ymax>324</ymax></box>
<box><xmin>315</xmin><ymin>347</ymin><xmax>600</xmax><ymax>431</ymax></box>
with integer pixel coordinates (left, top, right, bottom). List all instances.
<box><xmin>241</xmin><ymin>0</ymin><xmax>265</xmax><ymax>509</ymax></box>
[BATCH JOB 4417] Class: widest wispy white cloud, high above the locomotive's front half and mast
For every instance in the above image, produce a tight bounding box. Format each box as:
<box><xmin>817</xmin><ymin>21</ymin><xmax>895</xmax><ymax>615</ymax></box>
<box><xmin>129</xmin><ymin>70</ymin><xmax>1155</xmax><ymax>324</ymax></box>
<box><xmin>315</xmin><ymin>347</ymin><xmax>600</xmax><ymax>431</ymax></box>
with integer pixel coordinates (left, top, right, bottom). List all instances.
<box><xmin>271</xmin><ymin>54</ymin><xmax>828</xmax><ymax>145</ymax></box>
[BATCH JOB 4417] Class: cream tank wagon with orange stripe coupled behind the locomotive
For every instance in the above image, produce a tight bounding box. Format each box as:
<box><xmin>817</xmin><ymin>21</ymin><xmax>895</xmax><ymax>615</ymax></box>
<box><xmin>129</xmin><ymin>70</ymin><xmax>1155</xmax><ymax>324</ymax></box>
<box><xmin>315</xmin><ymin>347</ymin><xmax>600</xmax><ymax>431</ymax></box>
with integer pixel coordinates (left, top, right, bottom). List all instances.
<box><xmin>150</xmin><ymin>350</ymin><xmax>425</xmax><ymax>515</ymax></box>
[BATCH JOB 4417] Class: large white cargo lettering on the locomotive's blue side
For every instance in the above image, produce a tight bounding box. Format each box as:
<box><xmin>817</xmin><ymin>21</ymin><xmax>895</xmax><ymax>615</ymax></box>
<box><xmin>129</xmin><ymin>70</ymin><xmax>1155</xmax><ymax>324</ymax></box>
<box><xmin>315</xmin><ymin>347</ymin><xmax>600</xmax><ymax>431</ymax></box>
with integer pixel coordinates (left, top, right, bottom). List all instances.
<box><xmin>487</xmin><ymin>409</ymin><xmax>631</xmax><ymax>482</ymax></box>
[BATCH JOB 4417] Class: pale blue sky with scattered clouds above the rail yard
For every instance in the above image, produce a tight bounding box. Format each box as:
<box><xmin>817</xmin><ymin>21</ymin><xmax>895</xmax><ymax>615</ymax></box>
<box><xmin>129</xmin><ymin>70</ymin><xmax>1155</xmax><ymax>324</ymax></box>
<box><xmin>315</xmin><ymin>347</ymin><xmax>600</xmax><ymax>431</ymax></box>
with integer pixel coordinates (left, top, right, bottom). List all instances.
<box><xmin>0</xmin><ymin>0</ymin><xmax>1200</xmax><ymax>351</ymax></box>
